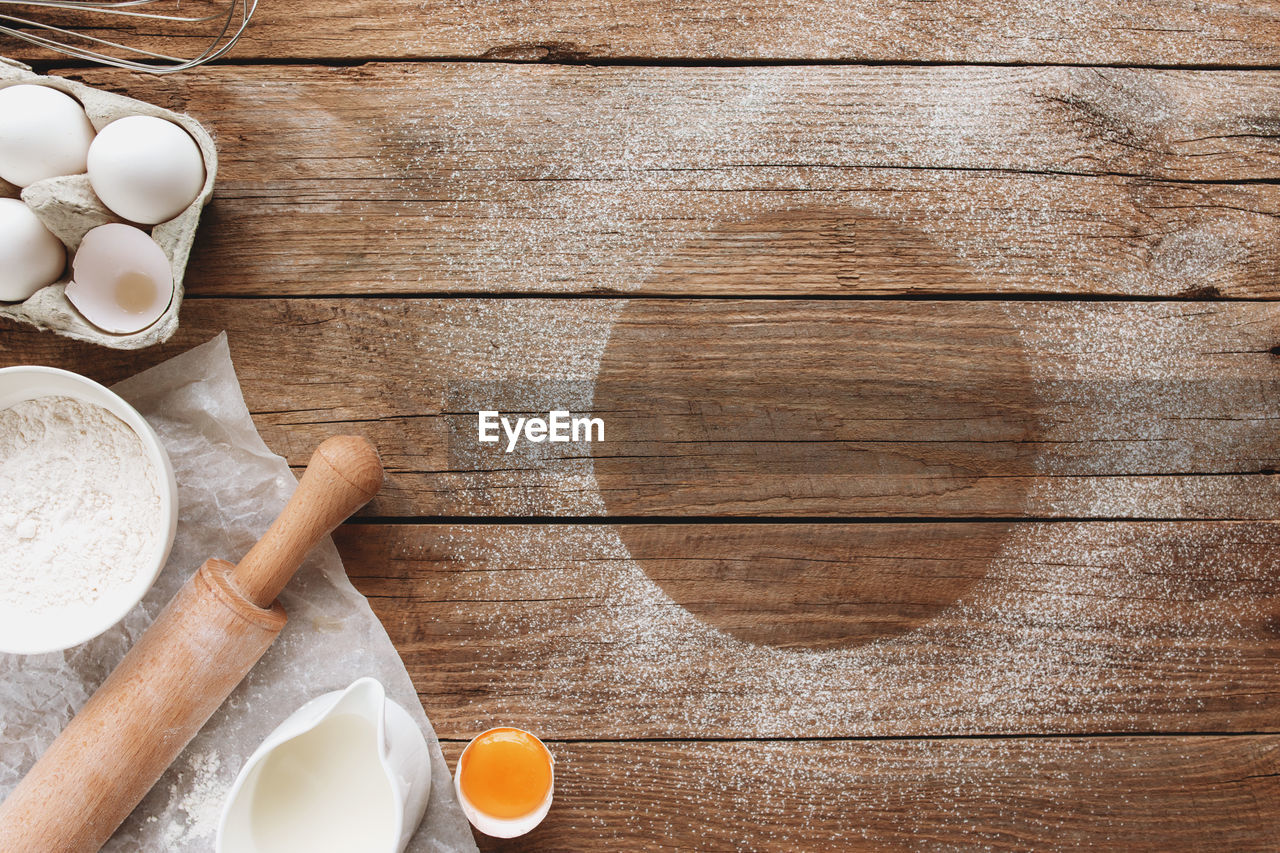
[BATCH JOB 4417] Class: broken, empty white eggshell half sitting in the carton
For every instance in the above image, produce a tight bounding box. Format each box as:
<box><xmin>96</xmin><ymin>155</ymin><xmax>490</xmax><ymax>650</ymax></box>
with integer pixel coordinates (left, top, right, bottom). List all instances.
<box><xmin>67</xmin><ymin>223</ymin><xmax>173</xmax><ymax>334</ymax></box>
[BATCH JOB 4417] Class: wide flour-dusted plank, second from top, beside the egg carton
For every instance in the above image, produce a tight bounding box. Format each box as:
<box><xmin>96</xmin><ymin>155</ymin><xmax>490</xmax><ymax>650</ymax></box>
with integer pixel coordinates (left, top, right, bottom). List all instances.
<box><xmin>52</xmin><ymin>64</ymin><xmax>1280</xmax><ymax>297</ymax></box>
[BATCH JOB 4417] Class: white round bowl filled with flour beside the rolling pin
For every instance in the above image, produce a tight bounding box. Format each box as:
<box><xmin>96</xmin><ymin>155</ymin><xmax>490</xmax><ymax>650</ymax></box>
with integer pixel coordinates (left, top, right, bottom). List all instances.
<box><xmin>0</xmin><ymin>366</ymin><xmax>178</xmax><ymax>654</ymax></box>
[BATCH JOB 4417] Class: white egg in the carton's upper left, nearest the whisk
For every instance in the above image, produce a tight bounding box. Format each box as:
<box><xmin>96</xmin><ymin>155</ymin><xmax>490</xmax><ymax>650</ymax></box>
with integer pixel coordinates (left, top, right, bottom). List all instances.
<box><xmin>0</xmin><ymin>83</ymin><xmax>93</xmax><ymax>187</ymax></box>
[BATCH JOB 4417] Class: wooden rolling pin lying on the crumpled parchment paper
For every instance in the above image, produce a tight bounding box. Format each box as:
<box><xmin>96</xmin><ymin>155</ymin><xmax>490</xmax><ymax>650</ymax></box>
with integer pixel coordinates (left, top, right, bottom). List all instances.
<box><xmin>0</xmin><ymin>435</ymin><xmax>383</xmax><ymax>853</ymax></box>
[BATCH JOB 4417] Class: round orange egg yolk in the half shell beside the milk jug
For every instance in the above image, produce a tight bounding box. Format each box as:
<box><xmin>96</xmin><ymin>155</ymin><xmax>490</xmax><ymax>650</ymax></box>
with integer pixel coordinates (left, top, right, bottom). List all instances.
<box><xmin>458</xmin><ymin>729</ymin><xmax>552</xmax><ymax>820</ymax></box>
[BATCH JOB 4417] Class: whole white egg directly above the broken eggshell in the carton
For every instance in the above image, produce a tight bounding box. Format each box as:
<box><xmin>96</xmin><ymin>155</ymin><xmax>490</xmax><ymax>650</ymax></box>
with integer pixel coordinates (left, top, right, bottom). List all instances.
<box><xmin>88</xmin><ymin>115</ymin><xmax>205</xmax><ymax>225</ymax></box>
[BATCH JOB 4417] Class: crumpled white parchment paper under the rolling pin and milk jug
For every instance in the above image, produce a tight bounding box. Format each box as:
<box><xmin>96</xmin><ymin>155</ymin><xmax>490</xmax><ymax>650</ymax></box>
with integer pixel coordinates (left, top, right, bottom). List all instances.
<box><xmin>0</xmin><ymin>334</ymin><xmax>476</xmax><ymax>853</ymax></box>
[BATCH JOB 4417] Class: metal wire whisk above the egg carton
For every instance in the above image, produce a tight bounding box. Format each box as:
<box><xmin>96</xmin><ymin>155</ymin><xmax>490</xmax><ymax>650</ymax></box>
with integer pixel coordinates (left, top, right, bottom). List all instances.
<box><xmin>0</xmin><ymin>0</ymin><xmax>257</xmax><ymax>74</ymax></box>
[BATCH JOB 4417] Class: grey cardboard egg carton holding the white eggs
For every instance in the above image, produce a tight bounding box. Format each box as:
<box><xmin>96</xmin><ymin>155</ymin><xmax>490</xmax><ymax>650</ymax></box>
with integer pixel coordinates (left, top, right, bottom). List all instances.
<box><xmin>0</xmin><ymin>56</ymin><xmax>218</xmax><ymax>350</ymax></box>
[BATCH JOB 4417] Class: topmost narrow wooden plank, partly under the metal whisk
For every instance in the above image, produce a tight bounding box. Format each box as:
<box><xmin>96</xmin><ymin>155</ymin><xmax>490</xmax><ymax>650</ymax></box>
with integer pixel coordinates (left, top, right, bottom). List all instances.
<box><xmin>15</xmin><ymin>0</ymin><xmax>1280</xmax><ymax>65</ymax></box>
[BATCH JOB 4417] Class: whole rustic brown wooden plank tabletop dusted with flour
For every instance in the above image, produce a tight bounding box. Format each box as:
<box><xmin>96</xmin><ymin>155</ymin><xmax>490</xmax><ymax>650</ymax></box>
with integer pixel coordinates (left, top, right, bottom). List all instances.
<box><xmin>0</xmin><ymin>0</ymin><xmax>1280</xmax><ymax>852</ymax></box>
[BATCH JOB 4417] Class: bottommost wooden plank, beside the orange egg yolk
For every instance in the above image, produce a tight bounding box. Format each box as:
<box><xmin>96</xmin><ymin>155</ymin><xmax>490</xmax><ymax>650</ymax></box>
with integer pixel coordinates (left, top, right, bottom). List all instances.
<box><xmin>432</xmin><ymin>736</ymin><xmax>1280</xmax><ymax>853</ymax></box>
